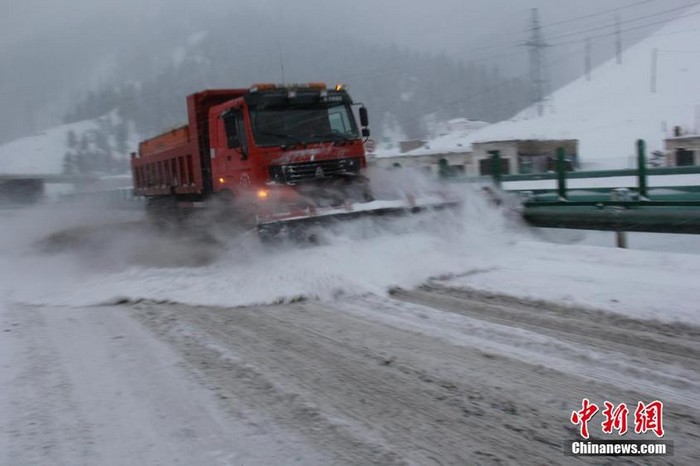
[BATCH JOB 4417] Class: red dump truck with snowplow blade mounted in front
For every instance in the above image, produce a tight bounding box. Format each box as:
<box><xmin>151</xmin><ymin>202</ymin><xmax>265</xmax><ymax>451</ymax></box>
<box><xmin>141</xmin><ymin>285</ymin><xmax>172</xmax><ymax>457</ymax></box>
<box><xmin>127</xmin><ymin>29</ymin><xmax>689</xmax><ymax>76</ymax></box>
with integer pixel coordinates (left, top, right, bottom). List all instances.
<box><xmin>131</xmin><ymin>83</ymin><xmax>454</xmax><ymax>238</ymax></box>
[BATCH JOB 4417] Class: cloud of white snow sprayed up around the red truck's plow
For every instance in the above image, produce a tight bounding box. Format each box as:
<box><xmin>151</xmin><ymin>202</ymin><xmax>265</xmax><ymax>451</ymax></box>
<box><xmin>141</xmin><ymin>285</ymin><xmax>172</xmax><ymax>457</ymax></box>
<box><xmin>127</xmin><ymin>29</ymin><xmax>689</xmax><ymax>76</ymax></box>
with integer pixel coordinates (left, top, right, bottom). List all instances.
<box><xmin>0</xmin><ymin>170</ymin><xmax>522</xmax><ymax>306</ymax></box>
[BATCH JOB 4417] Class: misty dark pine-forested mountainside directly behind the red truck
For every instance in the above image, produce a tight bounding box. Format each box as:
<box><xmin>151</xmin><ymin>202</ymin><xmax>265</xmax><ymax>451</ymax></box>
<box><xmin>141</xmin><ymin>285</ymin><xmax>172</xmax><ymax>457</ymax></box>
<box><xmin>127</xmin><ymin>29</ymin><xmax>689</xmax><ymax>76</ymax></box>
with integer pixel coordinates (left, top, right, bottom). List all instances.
<box><xmin>63</xmin><ymin>29</ymin><xmax>527</xmax><ymax>142</ymax></box>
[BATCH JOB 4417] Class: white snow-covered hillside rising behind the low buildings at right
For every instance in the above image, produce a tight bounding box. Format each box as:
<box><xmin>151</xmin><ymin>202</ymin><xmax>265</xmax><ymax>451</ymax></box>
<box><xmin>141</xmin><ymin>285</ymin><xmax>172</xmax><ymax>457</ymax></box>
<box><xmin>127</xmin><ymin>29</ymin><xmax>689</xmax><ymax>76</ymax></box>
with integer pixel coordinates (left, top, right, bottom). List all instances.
<box><xmin>462</xmin><ymin>3</ymin><xmax>700</xmax><ymax>168</ymax></box>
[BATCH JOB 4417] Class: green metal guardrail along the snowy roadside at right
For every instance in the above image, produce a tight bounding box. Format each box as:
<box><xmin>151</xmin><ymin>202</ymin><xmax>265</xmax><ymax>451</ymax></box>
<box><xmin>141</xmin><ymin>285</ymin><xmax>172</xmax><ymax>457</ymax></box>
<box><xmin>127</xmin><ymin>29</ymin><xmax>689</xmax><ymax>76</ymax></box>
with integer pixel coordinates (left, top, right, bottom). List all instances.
<box><xmin>446</xmin><ymin>139</ymin><xmax>700</xmax><ymax>233</ymax></box>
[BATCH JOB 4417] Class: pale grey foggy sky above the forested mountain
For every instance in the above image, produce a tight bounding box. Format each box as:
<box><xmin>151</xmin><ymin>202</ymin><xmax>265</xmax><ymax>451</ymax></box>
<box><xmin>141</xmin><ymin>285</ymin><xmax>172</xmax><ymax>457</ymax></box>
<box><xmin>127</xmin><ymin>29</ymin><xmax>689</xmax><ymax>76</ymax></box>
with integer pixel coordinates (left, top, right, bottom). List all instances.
<box><xmin>0</xmin><ymin>0</ymin><xmax>693</xmax><ymax>142</ymax></box>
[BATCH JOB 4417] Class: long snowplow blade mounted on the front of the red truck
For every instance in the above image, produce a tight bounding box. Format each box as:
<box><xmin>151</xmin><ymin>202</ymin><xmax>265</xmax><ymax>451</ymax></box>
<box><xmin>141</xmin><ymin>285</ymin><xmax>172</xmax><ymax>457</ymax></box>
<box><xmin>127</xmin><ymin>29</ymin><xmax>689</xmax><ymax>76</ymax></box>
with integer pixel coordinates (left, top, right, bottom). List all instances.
<box><xmin>257</xmin><ymin>197</ymin><xmax>461</xmax><ymax>241</ymax></box>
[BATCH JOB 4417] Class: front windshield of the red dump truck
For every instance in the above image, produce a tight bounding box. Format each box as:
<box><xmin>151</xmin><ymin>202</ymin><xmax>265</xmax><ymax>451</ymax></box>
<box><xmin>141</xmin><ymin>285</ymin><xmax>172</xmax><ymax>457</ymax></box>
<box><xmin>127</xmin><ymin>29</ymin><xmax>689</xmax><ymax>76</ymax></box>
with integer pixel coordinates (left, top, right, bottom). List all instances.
<box><xmin>250</xmin><ymin>102</ymin><xmax>359</xmax><ymax>146</ymax></box>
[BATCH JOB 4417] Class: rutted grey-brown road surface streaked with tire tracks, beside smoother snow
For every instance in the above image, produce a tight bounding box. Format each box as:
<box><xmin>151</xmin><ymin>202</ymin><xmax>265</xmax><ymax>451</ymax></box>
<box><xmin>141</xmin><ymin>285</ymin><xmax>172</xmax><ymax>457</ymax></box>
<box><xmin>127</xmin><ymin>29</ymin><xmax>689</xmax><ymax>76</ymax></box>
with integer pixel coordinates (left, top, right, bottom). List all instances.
<box><xmin>130</xmin><ymin>289</ymin><xmax>700</xmax><ymax>464</ymax></box>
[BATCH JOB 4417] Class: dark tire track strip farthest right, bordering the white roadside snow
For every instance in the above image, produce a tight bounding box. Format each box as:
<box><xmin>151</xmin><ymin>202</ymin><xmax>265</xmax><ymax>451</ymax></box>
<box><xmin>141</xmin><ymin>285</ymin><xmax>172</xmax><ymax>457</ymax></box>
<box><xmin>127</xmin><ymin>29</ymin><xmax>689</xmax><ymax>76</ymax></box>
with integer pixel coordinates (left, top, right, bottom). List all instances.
<box><xmin>392</xmin><ymin>286</ymin><xmax>700</xmax><ymax>406</ymax></box>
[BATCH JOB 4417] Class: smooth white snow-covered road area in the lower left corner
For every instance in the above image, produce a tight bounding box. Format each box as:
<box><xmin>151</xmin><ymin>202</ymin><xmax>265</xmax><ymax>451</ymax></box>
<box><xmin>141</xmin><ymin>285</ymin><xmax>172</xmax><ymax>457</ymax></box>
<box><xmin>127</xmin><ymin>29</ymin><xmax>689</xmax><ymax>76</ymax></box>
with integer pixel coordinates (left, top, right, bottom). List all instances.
<box><xmin>0</xmin><ymin>300</ymin><xmax>327</xmax><ymax>465</ymax></box>
